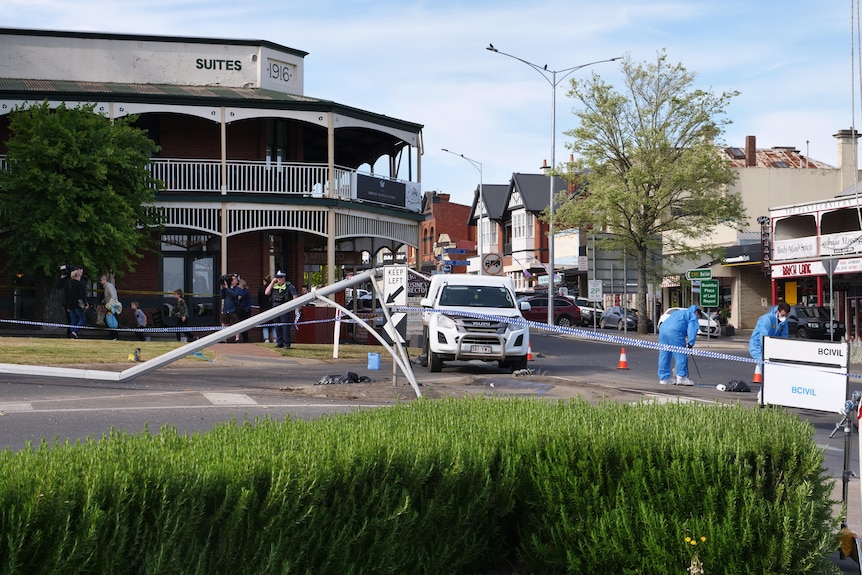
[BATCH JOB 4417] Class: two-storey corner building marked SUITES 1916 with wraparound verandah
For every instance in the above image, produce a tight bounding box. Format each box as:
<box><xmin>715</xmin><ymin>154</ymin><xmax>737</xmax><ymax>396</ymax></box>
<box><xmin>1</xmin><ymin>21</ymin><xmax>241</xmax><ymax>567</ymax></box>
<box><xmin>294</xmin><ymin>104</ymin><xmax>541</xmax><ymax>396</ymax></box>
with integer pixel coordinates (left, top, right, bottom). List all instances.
<box><xmin>0</xmin><ymin>29</ymin><xmax>423</xmax><ymax>324</ymax></box>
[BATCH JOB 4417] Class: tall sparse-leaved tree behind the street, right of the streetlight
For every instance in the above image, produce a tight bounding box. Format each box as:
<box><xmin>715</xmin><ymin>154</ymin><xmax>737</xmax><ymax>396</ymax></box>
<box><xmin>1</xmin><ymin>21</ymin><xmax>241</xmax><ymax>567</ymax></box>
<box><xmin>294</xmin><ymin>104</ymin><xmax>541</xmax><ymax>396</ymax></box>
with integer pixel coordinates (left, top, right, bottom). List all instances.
<box><xmin>556</xmin><ymin>51</ymin><xmax>746</xmax><ymax>333</ymax></box>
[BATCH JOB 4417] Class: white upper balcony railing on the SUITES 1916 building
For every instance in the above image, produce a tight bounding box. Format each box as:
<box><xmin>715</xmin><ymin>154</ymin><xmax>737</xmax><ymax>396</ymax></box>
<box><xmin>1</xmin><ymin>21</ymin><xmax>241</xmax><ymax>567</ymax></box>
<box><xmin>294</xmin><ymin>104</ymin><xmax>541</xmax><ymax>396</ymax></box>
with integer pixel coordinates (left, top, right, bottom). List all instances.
<box><xmin>150</xmin><ymin>158</ymin><xmax>354</xmax><ymax>199</ymax></box>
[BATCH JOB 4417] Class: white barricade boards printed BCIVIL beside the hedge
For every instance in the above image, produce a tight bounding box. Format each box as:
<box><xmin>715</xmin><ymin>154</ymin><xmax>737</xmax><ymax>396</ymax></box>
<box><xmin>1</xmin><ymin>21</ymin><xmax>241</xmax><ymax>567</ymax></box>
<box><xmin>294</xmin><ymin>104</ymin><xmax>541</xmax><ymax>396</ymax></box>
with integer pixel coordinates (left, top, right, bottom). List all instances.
<box><xmin>762</xmin><ymin>337</ymin><xmax>850</xmax><ymax>413</ymax></box>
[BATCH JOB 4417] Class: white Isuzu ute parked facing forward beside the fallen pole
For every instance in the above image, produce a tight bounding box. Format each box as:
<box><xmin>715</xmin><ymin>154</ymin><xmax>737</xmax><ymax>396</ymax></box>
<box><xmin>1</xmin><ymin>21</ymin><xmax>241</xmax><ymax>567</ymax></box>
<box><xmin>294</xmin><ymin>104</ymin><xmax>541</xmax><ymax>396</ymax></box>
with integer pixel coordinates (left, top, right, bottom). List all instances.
<box><xmin>420</xmin><ymin>274</ymin><xmax>530</xmax><ymax>372</ymax></box>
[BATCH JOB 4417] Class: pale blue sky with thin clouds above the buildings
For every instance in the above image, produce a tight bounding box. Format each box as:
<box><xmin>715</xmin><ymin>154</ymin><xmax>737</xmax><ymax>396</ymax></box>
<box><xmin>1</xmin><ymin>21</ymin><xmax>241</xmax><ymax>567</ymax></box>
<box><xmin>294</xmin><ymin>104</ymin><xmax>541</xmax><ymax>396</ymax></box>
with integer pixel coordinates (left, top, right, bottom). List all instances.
<box><xmin>0</xmin><ymin>0</ymin><xmax>862</xmax><ymax>204</ymax></box>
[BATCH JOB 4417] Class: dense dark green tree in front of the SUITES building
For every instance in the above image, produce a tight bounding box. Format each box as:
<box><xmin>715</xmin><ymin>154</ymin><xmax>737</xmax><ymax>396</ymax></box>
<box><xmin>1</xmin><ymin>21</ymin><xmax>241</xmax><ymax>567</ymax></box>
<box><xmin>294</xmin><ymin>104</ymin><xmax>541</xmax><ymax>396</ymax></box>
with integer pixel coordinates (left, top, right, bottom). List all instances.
<box><xmin>0</xmin><ymin>102</ymin><xmax>159</xmax><ymax>321</ymax></box>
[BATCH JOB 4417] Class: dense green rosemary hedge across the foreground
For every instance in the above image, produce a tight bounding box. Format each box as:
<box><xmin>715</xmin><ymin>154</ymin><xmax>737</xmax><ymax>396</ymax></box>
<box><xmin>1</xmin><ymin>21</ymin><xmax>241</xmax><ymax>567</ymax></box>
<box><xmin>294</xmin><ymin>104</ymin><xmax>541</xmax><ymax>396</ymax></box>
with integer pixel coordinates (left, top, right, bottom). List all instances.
<box><xmin>0</xmin><ymin>398</ymin><xmax>837</xmax><ymax>575</ymax></box>
